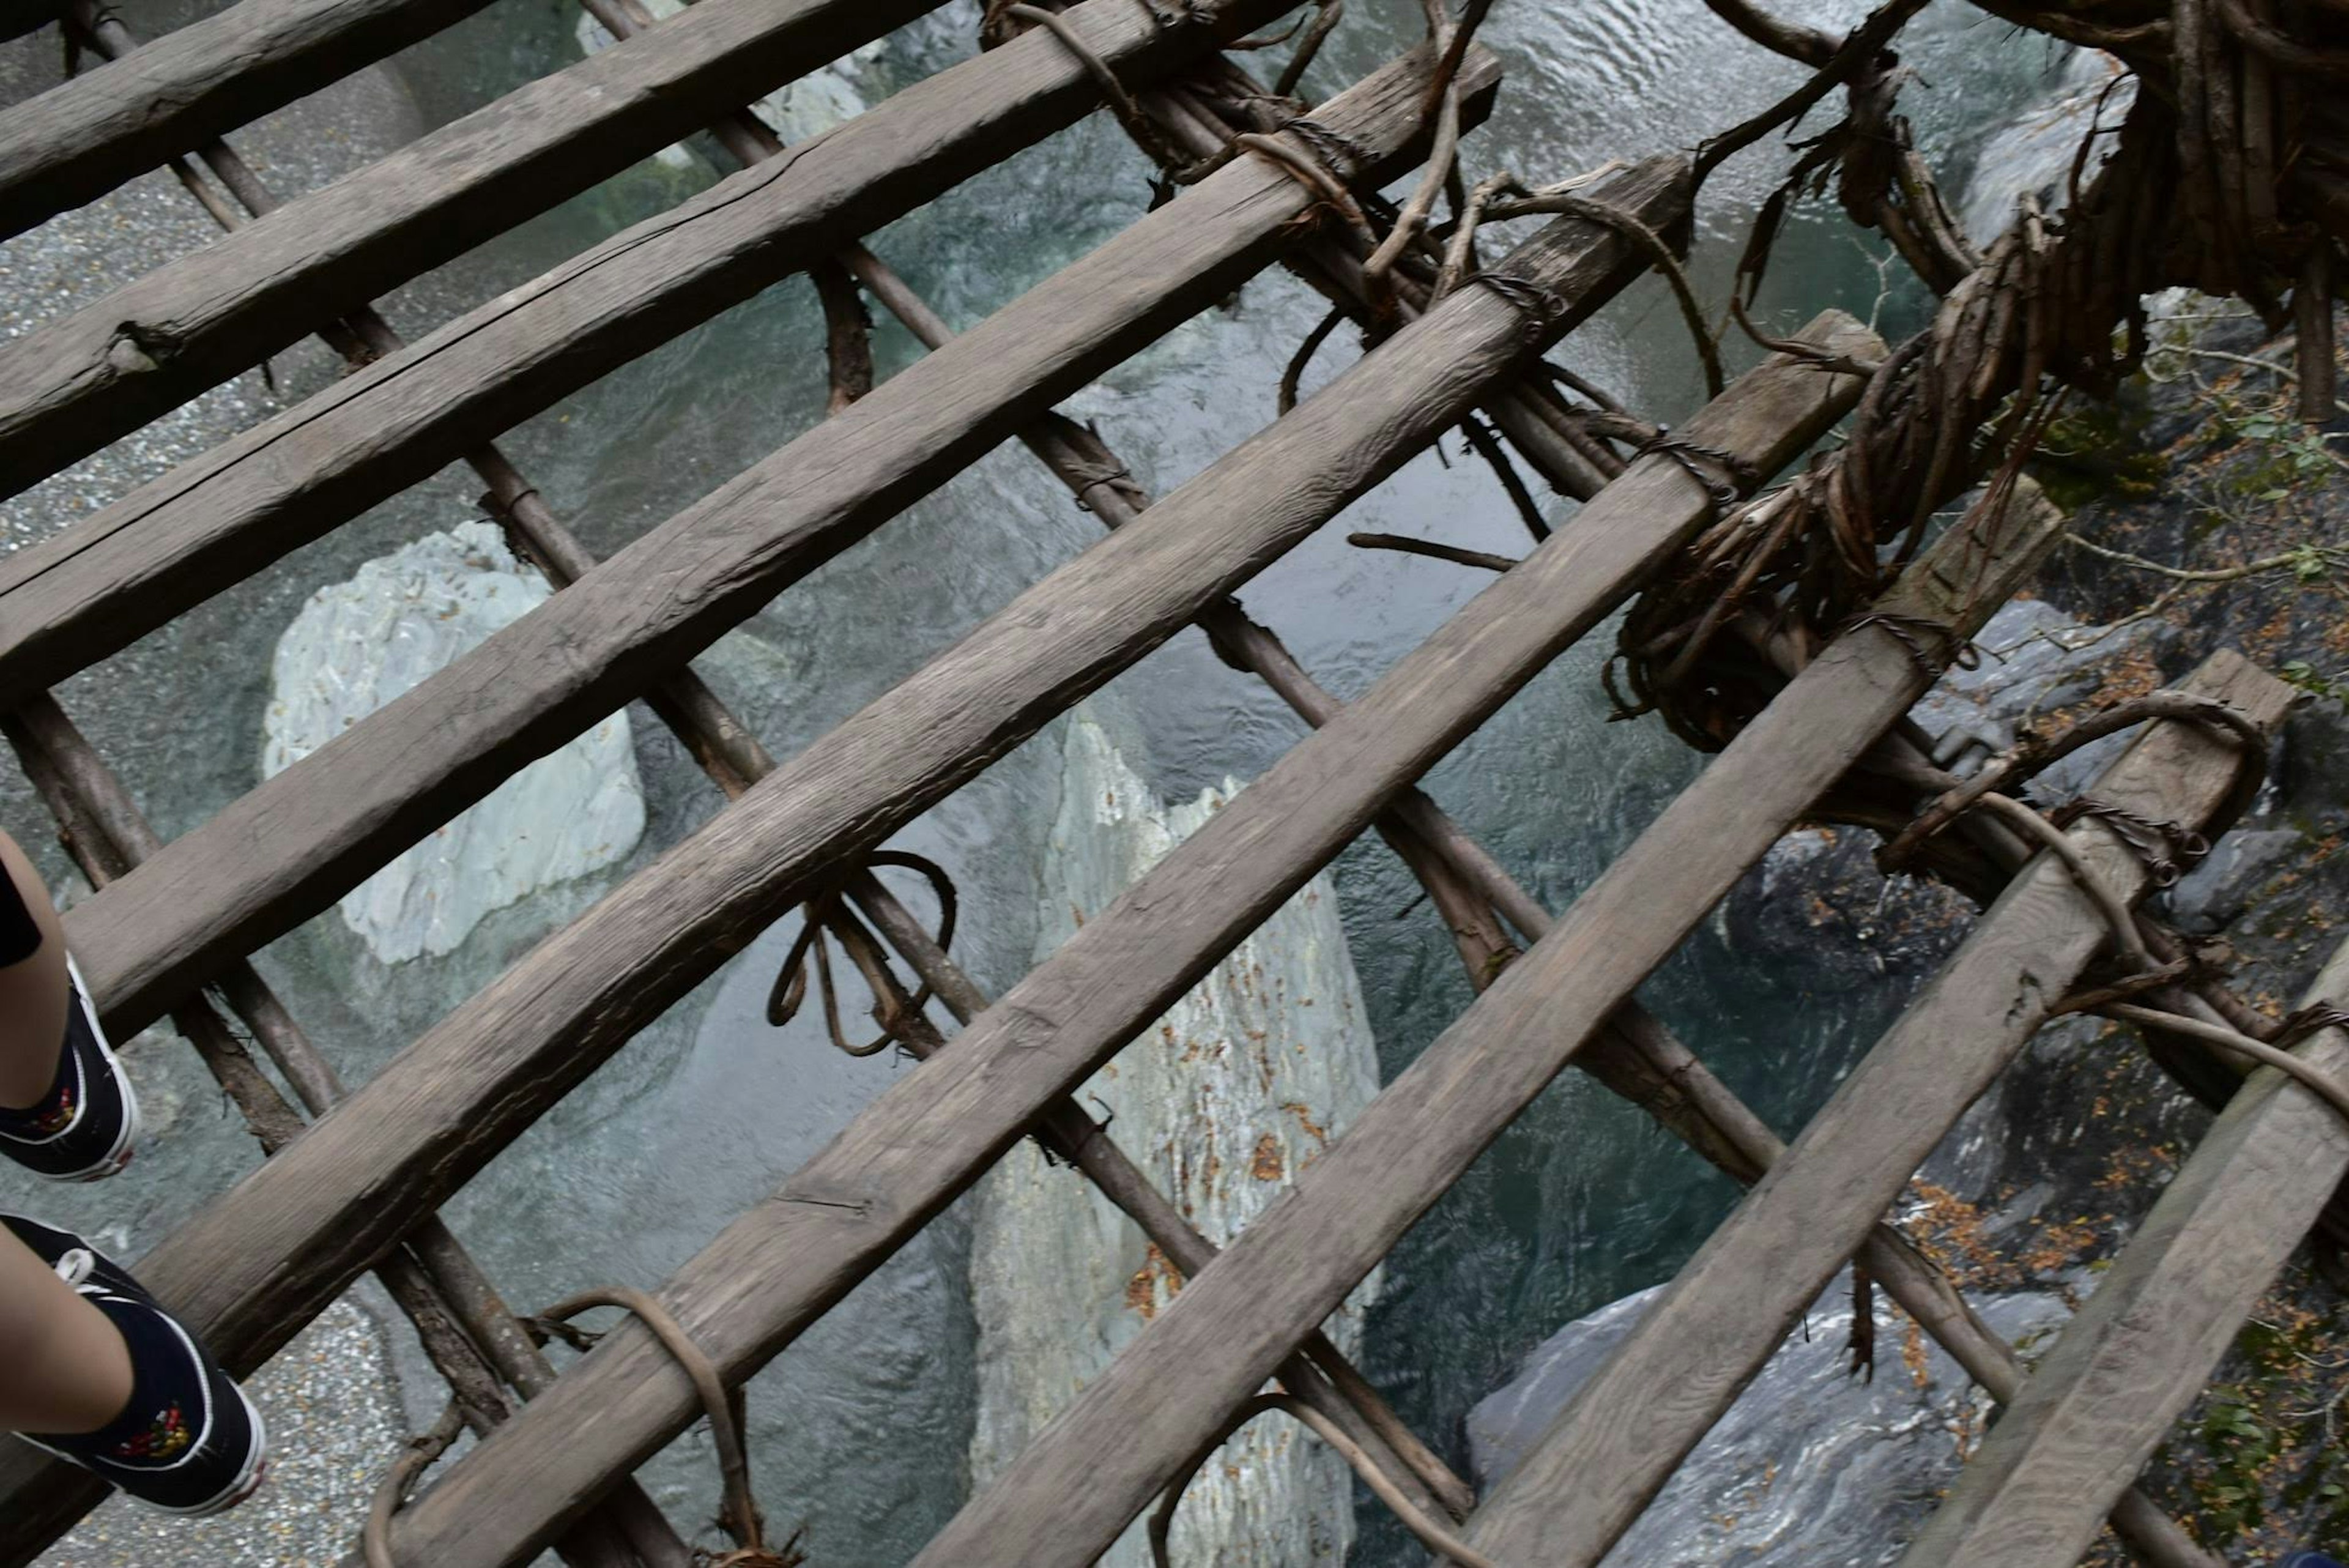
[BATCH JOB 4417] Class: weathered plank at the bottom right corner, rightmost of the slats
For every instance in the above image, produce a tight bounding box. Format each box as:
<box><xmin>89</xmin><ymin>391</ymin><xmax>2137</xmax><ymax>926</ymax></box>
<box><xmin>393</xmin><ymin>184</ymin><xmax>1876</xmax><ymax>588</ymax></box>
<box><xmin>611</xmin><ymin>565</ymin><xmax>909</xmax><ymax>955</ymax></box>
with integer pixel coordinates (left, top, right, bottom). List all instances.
<box><xmin>1901</xmin><ymin>943</ymin><xmax>2349</xmax><ymax>1568</ymax></box>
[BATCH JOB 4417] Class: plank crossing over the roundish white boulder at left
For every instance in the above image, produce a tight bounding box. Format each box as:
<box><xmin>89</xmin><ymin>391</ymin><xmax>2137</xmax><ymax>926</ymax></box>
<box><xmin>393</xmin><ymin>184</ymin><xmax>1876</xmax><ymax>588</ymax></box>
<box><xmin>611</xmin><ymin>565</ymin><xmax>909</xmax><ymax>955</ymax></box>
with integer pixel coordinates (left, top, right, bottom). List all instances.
<box><xmin>68</xmin><ymin>46</ymin><xmax>1512</xmax><ymax>1032</ymax></box>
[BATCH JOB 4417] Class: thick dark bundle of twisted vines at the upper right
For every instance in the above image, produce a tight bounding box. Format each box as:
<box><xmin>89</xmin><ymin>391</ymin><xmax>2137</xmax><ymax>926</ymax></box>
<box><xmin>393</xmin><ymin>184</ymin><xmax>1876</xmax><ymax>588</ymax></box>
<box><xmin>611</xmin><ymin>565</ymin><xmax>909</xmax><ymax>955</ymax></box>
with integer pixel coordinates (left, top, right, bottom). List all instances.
<box><xmin>1609</xmin><ymin>84</ymin><xmax>2175</xmax><ymax>750</ymax></box>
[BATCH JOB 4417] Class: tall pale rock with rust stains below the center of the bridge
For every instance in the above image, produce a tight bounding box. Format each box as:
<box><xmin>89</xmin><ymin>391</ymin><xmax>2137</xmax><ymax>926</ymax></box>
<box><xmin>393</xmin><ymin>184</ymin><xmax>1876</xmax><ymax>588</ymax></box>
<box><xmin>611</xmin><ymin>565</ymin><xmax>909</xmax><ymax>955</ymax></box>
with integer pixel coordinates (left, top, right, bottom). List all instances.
<box><xmin>970</xmin><ymin>717</ymin><xmax>1379</xmax><ymax>1568</ymax></box>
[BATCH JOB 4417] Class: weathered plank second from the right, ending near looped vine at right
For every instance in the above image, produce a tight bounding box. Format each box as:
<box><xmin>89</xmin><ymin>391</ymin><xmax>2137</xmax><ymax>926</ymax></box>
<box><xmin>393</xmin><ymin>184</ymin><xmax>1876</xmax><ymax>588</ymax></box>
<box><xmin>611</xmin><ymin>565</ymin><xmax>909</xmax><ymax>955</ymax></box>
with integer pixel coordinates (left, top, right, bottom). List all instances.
<box><xmin>1466</xmin><ymin>653</ymin><xmax>2293</xmax><ymax>1568</ymax></box>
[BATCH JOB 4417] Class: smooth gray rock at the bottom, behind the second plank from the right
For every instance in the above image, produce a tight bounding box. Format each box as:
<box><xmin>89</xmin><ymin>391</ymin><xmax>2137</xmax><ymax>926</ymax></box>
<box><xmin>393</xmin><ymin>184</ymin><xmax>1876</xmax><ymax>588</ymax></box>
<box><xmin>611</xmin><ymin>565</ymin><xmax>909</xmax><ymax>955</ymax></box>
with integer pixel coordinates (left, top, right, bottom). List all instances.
<box><xmin>1468</xmin><ymin>1272</ymin><xmax>2065</xmax><ymax>1568</ymax></box>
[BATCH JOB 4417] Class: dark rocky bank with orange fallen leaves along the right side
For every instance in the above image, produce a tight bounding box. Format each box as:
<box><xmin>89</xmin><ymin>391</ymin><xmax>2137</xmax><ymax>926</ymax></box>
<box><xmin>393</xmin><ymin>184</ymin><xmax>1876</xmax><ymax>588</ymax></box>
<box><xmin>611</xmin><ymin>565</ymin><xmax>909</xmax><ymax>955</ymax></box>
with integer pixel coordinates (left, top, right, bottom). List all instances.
<box><xmin>1468</xmin><ymin>299</ymin><xmax>2349</xmax><ymax>1568</ymax></box>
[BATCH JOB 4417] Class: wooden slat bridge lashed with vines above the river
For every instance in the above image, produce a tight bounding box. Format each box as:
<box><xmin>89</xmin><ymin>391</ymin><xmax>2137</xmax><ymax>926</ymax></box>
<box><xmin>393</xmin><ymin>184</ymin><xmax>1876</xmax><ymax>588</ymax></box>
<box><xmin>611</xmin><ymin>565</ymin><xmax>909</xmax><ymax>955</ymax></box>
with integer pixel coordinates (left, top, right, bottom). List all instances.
<box><xmin>0</xmin><ymin>0</ymin><xmax>2349</xmax><ymax>1568</ymax></box>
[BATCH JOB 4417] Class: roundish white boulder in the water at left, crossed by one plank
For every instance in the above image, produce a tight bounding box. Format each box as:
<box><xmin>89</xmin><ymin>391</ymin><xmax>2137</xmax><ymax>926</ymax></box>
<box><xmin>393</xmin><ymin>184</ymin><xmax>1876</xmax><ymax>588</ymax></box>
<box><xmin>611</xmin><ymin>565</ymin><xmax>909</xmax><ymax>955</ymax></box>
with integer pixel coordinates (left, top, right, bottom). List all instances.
<box><xmin>261</xmin><ymin>522</ymin><xmax>644</xmax><ymax>964</ymax></box>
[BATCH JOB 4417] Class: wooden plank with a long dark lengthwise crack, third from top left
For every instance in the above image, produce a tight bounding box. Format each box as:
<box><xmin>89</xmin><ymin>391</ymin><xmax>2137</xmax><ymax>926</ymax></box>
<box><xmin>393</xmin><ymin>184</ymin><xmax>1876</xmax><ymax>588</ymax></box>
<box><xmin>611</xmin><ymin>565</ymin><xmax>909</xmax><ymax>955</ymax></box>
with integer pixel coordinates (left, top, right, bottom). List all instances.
<box><xmin>0</xmin><ymin>0</ymin><xmax>1287</xmax><ymax>689</ymax></box>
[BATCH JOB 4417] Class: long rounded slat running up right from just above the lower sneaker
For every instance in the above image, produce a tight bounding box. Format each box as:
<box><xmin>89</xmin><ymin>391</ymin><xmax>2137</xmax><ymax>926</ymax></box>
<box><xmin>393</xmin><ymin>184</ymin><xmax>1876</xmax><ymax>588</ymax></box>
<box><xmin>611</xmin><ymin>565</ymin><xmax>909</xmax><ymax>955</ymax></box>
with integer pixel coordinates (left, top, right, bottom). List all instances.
<box><xmin>0</xmin><ymin>152</ymin><xmax>1687</xmax><ymax>1533</ymax></box>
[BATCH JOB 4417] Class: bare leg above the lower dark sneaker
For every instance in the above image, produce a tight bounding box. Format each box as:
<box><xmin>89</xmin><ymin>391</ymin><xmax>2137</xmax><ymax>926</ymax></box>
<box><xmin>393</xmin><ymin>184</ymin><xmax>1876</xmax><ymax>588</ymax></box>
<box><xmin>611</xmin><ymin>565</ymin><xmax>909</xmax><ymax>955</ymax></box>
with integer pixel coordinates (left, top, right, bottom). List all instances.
<box><xmin>0</xmin><ymin>1232</ymin><xmax>132</xmax><ymax>1434</ymax></box>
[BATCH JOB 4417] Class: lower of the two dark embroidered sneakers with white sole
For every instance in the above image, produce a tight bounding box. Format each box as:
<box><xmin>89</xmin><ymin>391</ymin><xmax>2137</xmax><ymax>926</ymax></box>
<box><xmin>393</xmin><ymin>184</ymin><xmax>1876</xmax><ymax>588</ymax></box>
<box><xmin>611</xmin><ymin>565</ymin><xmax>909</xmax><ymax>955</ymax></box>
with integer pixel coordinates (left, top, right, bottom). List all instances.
<box><xmin>0</xmin><ymin>1216</ymin><xmax>268</xmax><ymax>1514</ymax></box>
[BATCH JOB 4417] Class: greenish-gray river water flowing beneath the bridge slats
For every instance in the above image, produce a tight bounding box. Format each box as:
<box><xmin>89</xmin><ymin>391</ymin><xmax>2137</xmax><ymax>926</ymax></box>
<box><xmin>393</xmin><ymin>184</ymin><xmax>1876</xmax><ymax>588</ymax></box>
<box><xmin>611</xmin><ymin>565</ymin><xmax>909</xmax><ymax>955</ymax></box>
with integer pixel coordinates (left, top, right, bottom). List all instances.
<box><xmin>0</xmin><ymin>0</ymin><xmax>2081</xmax><ymax>1563</ymax></box>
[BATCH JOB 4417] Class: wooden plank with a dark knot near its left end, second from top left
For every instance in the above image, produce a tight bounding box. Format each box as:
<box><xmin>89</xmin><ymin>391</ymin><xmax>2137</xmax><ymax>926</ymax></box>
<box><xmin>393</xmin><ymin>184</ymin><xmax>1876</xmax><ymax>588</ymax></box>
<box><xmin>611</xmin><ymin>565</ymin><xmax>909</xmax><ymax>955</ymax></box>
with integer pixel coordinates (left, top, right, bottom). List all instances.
<box><xmin>0</xmin><ymin>0</ymin><xmax>1283</xmax><ymax>496</ymax></box>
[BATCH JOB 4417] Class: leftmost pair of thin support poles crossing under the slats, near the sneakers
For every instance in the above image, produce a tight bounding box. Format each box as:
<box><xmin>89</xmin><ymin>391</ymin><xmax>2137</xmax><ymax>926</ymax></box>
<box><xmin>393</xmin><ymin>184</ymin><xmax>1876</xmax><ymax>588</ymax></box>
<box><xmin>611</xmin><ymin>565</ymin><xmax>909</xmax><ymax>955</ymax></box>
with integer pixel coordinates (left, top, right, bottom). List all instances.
<box><xmin>0</xmin><ymin>694</ymin><xmax>691</xmax><ymax>1568</ymax></box>
